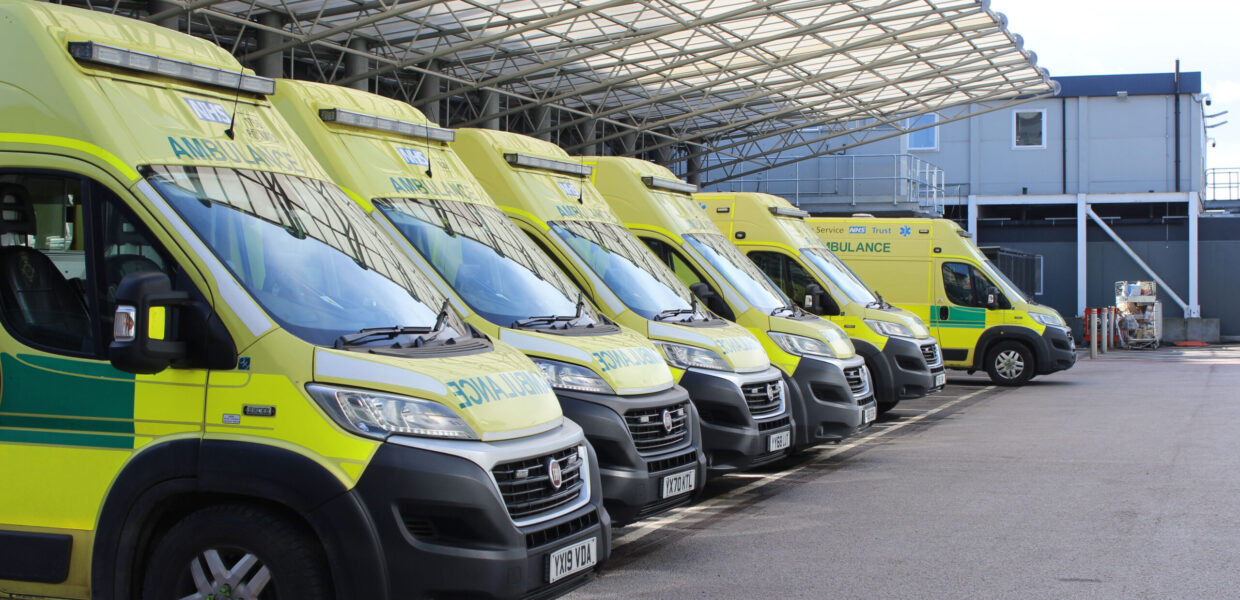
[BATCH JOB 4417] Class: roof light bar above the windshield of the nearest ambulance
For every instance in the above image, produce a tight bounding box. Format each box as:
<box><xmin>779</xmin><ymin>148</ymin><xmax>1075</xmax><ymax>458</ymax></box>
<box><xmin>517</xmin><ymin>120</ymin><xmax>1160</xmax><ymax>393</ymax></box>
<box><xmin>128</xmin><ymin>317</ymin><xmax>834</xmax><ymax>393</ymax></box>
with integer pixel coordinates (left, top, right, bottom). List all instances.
<box><xmin>69</xmin><ymin>42</ymin><xmax>275</xmax><ymax>95</ymax></box>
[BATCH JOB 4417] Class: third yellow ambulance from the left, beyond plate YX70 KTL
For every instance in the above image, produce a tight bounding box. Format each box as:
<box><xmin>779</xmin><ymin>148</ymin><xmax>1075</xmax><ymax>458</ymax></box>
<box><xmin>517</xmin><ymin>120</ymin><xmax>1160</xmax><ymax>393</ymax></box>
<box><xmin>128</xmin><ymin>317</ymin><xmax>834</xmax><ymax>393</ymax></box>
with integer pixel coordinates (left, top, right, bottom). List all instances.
<box><xmin>454</xmin><ymin>129</ymin><xmax>792</xmax><ymax>474</ymax></box>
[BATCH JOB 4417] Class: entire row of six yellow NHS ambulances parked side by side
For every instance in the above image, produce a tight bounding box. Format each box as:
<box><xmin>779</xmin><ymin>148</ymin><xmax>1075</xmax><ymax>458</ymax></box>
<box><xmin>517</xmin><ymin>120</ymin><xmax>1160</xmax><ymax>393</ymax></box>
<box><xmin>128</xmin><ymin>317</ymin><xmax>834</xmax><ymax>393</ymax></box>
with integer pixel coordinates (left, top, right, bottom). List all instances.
<box><xmin>0</xmin><ymin>0</ymin><xmax>1074</xmax><ymax>600</ymax></box>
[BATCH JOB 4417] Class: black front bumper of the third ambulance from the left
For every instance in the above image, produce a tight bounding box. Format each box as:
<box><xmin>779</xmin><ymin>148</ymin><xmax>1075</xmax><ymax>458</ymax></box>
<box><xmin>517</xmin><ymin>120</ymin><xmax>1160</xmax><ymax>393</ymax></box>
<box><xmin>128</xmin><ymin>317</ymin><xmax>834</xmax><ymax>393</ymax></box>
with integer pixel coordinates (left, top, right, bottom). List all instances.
<box><xmin>680</xmin><ymin>367</ymin><xmax>795</xmax><ymax>475</ymax></box>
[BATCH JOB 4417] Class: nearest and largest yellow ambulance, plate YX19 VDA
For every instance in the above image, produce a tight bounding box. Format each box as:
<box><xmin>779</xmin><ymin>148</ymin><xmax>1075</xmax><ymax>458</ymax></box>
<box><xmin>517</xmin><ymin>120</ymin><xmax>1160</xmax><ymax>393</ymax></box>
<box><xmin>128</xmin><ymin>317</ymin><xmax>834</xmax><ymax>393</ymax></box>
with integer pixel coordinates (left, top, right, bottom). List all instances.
<box><xmin>0</xmin><ymin>0</ymin><xmax>610</xmax><ymax>600</ymax></box>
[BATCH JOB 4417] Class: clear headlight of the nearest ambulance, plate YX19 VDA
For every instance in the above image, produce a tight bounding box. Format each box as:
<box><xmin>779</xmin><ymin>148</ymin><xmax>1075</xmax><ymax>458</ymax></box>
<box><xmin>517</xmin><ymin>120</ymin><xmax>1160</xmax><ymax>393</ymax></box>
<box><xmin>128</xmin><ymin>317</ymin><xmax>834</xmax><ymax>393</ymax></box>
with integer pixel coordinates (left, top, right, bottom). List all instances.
<box><xmin>306</xmin><ymin>383</ymin><xmax>479</xmax><ymax>440</ymax></box>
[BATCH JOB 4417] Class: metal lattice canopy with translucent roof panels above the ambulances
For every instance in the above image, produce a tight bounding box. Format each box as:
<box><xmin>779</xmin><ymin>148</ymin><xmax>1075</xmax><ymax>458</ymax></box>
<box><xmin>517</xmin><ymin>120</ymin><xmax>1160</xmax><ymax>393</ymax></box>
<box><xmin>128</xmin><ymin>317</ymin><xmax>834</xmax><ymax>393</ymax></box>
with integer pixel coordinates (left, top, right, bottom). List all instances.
<box><xmin>69</xmin><ymin>0</ymin><xmax>1054</xmax><ymax>185</ymax></box>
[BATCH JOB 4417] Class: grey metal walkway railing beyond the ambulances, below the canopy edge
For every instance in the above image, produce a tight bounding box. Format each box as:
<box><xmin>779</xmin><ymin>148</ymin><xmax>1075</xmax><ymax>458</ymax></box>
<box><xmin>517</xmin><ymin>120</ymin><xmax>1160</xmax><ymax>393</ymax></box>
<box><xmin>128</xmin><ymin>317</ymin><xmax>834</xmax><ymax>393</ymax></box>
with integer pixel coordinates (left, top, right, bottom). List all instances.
<box><xmin>718</xmin><ymin>154</ymin><xmax>947</xmax><ymax>213</ymax></box>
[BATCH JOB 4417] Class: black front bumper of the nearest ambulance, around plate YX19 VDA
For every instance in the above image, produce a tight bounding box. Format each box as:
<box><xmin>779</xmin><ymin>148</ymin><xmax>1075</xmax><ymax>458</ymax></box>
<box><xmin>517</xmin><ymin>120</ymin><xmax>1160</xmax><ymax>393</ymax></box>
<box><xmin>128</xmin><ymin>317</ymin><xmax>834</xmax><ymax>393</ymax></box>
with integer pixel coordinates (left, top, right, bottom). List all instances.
<box><xmin>347</xmin><ymin>436</ymin><xmax>611</xmax><ymax>599</ymax></box>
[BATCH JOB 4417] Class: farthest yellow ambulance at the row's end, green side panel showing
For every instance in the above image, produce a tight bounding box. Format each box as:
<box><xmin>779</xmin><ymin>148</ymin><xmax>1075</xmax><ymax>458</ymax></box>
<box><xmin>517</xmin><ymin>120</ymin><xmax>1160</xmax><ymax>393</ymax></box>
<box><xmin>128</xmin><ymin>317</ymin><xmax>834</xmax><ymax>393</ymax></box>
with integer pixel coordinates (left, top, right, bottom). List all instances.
<box><xmin>808</xmin><ymin>216</ymin><xmax>1076</xmax><ymax>386</ymax></box>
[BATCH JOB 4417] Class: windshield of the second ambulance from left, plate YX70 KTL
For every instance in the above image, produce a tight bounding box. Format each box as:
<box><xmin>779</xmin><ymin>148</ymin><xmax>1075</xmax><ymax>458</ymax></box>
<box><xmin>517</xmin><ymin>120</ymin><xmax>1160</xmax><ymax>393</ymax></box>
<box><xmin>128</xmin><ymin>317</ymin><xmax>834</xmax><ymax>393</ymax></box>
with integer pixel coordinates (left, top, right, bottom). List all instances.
<box><xmin>374</xmin><ymin>198</ymin><xmax>599</xmax><ymax>329</ymax></box>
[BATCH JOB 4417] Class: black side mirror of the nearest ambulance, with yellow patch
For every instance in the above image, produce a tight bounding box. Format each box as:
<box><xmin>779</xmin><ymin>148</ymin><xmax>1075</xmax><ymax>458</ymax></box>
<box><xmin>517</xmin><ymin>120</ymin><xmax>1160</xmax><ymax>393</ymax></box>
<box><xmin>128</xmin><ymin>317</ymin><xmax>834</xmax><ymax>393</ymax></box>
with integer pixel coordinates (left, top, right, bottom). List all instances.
<box><xmin>108</xmin><ymin>271</ymin><xmax>190</xmax><ymax>374</ymax></box>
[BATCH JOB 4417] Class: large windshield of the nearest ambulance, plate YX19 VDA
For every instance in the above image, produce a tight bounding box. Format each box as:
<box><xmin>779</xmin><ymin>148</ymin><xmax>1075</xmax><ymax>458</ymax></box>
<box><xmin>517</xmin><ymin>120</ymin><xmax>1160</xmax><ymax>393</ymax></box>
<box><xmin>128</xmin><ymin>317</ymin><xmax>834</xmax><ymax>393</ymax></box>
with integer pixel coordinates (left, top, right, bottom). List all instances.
<box><xmin>146</xmin><ymin>166</ymin><xmax>467</xmax><ymax>346</ymax></box>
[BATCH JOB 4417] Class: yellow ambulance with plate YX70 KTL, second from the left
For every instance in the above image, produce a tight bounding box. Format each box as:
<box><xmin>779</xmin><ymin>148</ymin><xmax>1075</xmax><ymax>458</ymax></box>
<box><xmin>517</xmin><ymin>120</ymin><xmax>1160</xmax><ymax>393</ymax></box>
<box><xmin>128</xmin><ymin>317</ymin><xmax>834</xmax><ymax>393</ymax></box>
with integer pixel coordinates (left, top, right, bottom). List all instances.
<box><xmin>272</xmin><ymin>79</ymin><xmax>706</xmax><ymax>523</ymax></box>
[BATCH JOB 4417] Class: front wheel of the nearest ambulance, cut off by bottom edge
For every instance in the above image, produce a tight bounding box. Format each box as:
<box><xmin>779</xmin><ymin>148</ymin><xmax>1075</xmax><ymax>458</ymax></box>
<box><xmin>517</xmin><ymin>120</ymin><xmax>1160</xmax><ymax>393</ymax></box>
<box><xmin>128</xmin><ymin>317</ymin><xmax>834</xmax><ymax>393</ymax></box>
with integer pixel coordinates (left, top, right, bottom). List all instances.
<box><xmin>143</xmin><ymin>505</ymin><xmax>334</xmax><ymax>600</ymax></box>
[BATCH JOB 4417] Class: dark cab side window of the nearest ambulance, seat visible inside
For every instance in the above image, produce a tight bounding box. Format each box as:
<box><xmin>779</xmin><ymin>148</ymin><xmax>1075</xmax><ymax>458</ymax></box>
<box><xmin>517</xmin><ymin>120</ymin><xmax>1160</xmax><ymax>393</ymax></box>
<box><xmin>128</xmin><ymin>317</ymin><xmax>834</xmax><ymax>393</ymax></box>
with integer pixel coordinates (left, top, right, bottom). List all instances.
<box><xmin>0</xmin><ymin>171</ymin><xmax>175</xmax><ymax>358</ymax></box>
